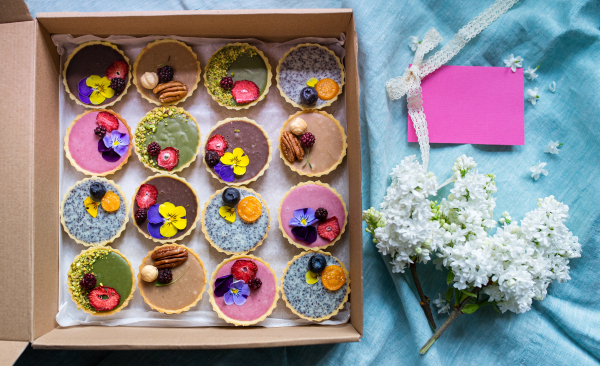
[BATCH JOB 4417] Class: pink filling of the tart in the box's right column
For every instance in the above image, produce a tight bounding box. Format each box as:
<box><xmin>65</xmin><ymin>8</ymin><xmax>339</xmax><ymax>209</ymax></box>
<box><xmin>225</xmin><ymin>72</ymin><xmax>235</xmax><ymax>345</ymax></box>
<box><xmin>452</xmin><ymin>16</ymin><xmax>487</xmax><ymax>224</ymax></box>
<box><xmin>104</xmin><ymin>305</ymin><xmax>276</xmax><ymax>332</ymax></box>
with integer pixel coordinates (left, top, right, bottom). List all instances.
<box><xmin>279</xmin><ymin>184</ymin><xmax>346</xmax><ymax>248</ymax></box>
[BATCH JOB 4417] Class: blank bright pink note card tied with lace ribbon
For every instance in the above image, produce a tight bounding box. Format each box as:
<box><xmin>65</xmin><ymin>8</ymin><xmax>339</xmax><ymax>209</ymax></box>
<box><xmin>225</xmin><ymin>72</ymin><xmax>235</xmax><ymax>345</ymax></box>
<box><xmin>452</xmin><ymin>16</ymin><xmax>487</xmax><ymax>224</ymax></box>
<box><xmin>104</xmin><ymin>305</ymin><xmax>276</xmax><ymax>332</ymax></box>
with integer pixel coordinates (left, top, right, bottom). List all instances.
<box><xmin>408</xmin><ymin>66</ymin><xmax>525</xmax><ymax>145</ymax></box>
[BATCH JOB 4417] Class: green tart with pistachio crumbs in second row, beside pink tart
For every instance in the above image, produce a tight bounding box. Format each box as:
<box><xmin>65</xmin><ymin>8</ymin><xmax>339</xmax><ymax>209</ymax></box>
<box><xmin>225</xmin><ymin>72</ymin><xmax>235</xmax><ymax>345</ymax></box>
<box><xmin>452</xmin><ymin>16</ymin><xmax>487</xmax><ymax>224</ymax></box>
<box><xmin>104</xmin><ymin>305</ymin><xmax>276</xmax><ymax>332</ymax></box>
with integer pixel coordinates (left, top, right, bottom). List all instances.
<box><xmin>134</xmin><ymin>107</ymin><xmax>202</xmax><ymax>174</ymax></box>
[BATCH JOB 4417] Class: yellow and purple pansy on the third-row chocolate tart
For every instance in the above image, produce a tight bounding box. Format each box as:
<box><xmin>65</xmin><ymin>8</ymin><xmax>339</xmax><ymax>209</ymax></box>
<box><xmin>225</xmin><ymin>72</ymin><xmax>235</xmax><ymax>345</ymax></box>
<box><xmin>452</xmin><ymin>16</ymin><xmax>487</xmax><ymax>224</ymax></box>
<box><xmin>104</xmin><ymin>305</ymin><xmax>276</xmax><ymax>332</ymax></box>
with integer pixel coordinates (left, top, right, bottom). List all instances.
<box><xmin>148</xmin><ymin>202</ymin><xmax>187</xmax><ymax>239</ymax></box>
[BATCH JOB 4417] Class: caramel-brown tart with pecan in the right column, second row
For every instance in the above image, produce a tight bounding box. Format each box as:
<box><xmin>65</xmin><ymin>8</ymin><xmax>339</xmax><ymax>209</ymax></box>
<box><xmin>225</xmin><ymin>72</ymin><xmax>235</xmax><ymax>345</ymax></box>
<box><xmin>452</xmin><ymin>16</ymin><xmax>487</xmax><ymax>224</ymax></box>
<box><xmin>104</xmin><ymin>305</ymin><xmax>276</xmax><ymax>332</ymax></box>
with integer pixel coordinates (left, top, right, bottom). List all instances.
<box><xmin>279</xmin><ymin>110</ymin><xmax>348</xmax><ymax>177</ymax></box>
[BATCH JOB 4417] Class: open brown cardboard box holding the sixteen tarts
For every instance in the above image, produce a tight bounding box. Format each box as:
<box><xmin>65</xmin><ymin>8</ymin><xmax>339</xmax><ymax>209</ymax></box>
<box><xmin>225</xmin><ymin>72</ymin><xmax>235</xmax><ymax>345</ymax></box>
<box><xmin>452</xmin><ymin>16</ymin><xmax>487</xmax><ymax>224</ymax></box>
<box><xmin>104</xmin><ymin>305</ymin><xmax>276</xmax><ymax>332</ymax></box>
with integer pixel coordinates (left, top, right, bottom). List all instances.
<box><xmin>0</xmin><ymin>0</ymin><xmax>363</xmax><ymax>361</ymax></box>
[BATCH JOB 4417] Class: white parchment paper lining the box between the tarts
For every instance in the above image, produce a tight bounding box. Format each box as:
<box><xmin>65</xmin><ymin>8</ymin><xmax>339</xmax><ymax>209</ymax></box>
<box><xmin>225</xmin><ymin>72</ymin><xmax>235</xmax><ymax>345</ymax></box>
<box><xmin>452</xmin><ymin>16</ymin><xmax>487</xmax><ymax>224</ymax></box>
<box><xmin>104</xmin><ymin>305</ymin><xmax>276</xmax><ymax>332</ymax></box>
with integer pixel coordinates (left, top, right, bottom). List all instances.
<box><xmin>52</xmin><ymin>34</ymin><xmax>350</xmax><ymax>327</ymax></box>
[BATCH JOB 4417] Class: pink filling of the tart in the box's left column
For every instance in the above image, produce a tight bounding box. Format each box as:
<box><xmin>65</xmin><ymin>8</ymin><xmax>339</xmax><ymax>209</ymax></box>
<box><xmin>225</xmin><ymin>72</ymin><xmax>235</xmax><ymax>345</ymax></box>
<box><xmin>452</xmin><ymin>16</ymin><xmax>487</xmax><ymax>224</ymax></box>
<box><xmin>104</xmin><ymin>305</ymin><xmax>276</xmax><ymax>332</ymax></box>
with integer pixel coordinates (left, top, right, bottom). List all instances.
<box><xmin>69</xmin><ymin>112</ymin><xmax>129</xmax><ymax>173</ymax></box>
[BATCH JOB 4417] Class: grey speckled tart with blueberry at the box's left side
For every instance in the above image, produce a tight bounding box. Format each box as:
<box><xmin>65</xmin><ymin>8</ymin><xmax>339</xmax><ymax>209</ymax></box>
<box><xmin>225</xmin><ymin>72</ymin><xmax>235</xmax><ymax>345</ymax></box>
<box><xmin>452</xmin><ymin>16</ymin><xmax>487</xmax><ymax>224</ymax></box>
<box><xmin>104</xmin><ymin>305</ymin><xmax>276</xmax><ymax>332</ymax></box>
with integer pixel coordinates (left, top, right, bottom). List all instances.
<box><xmin>60</xmin><ymin>177</ymin><xmax>129</xmax><ymax>246</ymax></box>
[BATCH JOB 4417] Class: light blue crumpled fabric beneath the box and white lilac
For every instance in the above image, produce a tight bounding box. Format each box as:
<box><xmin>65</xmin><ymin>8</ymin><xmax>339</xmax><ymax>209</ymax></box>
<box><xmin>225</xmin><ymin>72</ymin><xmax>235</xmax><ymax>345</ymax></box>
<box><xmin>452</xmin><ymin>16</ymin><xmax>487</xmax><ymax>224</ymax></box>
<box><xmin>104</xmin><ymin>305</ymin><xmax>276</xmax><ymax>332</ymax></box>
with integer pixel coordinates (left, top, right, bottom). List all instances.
<box><xmin>19</xmin><ymin>0</ymin><xmax>600</xmax><ymax>365</ymax></box>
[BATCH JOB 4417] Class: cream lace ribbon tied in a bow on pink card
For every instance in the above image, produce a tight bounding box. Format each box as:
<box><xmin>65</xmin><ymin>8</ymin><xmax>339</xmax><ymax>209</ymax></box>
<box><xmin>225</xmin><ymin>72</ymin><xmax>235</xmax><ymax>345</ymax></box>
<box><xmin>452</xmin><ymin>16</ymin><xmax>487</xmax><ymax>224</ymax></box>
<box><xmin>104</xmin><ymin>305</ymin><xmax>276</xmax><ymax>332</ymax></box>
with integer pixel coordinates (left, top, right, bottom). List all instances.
<box><xmin>386</xmin><ymin>0</ymin><xmax>519</xmax><ymax>170</ymax></box>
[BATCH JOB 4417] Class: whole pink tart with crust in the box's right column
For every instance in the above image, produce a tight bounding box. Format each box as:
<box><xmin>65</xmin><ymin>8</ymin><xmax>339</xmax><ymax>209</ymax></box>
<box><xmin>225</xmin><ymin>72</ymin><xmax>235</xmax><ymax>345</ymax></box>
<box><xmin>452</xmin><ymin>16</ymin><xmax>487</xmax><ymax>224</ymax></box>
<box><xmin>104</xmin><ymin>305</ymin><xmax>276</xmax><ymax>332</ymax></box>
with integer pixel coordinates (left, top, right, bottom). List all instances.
<box><xmin>277</xmin><ymin>181</ymin><xmax>348</xmax><ymax>251</ymax></box>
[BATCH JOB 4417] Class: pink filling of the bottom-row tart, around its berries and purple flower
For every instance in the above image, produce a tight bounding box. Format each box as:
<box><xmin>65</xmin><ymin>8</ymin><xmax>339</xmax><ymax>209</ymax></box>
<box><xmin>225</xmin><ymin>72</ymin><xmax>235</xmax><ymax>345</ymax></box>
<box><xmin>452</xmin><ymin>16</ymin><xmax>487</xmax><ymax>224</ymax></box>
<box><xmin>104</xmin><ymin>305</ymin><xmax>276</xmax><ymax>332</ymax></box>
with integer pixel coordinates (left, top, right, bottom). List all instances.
<box><xmin>211</xmin><ymin>260</ymin><xmax>276</xmax><ymax>321</ymax></box>
